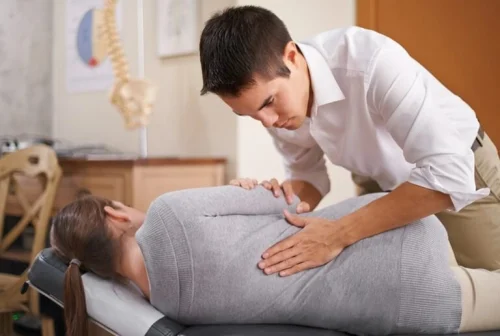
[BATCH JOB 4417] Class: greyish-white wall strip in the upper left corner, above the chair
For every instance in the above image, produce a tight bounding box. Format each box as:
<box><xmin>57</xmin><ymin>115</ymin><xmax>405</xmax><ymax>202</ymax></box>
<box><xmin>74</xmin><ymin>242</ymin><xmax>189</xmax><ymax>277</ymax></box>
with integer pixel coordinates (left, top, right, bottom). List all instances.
<box><xmin>0</xmin><ymin>0</ymin><xmax>52</xmax><ymax>138</ymax></box>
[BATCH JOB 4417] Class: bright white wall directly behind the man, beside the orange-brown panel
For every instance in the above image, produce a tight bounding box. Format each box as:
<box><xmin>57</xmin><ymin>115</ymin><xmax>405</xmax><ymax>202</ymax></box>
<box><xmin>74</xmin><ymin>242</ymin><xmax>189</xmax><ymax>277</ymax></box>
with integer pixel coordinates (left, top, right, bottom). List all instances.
<box><xmin>237</xmin><ymin>0</ymin><xmax>355</xmax><ymax>207</ymax></box>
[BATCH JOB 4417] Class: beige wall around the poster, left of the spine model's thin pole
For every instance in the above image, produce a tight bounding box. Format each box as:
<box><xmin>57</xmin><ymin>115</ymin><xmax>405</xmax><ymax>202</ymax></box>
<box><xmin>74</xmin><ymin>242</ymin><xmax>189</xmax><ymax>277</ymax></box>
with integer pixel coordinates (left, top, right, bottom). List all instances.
<box><xmin>52</xmin><ymin>1</ymin><xmax>138</xmax><ymax>151</ymax></box>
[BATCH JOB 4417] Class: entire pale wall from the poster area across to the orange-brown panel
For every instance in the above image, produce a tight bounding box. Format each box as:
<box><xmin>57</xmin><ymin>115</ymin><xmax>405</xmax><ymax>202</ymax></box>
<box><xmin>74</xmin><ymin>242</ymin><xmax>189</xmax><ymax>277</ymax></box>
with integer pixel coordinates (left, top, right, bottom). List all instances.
<box><xmin>53</xmin><ymin>0</ymin><xmax>355</xmax><ymax>204</ymax></box>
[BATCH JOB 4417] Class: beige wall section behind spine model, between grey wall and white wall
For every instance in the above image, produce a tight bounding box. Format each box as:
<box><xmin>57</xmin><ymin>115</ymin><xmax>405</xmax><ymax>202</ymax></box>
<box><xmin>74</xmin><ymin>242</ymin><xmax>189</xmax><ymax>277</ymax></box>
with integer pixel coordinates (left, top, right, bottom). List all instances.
<box><xmin>53</xmin><ymin>0</ymin><xmax>236</xmax><ymax>175</ymax></box>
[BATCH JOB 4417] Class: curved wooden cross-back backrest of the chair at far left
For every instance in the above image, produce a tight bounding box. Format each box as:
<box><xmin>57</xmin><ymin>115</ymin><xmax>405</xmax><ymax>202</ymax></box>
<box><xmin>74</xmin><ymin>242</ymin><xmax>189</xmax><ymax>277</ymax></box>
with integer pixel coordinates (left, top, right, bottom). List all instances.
<box><xmin>0</xmin><ymin>145</ymin><xmax>62</xmax><ymax>261</ymax></box>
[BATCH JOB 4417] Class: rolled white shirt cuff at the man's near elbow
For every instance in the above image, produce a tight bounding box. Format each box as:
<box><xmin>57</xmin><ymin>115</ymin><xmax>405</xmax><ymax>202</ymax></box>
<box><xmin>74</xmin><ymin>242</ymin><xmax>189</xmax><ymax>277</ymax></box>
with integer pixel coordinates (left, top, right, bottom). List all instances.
<box><xmin>408</xmin><ymin>157</ymin><xmax>490</xmax><ymax>212</ymax></box>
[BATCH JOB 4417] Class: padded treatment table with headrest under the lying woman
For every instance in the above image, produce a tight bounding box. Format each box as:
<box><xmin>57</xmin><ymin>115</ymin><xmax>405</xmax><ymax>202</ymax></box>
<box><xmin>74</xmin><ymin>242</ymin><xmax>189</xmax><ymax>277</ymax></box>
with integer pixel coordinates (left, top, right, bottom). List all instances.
<box><xmin>27</xmin><ymin>248</ymin><xmax>500</xmax><ymax>336</ymax></box>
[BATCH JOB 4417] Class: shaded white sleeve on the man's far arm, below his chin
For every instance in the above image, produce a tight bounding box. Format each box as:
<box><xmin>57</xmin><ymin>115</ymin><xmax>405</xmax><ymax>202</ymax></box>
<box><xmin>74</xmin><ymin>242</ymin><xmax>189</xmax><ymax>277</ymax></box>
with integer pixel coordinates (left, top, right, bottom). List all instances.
<box><xmin>269</xmin><ymin>130</ymin><xmax>330</xmax><ymax>197</ymax></box>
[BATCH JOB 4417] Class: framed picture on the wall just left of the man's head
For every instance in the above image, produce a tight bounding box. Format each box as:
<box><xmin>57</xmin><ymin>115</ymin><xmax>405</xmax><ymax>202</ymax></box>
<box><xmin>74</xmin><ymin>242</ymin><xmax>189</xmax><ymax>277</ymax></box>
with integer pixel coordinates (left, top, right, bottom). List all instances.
<box><xmin>156</xmin><ymin>0</ymin><xmax>199</xmax><ymax>57</ymax></box>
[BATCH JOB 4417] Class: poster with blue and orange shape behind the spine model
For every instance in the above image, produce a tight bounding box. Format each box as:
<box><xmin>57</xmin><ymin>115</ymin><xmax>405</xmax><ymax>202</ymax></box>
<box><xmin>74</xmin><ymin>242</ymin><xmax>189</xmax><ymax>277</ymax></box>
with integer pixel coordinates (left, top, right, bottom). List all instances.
<box><xmin>65</xmin><ymin>0</ymin><xmax>122</xmax><ymax>93</ymax></box>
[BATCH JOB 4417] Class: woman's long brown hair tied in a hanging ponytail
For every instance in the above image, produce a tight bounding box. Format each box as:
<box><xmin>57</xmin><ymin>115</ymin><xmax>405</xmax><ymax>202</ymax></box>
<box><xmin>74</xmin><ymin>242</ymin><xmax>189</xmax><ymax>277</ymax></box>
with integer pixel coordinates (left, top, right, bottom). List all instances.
<box><xmin>50</xmin><ymin>196</ymin><xmax>119</xmax><ymax>336</ymax></box>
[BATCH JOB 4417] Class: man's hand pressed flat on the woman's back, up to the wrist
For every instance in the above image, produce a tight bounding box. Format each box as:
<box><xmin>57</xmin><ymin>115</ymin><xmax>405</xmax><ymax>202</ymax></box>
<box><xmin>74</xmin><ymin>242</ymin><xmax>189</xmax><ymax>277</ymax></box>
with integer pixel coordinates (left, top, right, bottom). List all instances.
<box><xmin>258</xmin><ymin>210</ymin><xmax>348</xmax><ymax>276</ymax></box>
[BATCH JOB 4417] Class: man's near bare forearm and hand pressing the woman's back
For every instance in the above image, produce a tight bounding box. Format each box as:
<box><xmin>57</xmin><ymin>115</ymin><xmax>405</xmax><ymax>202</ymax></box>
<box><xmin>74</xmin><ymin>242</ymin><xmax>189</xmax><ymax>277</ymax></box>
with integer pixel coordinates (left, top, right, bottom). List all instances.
<box><xmin>259</xmin><ymin>182</ymin><xmax>453</xmax><ymax>276</ymax></box>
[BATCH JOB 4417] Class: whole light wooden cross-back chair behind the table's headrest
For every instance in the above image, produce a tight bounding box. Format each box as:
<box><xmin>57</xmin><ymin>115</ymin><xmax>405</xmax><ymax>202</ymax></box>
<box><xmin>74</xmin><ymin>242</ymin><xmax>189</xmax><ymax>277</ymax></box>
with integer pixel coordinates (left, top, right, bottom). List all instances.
<box><xmin>0</xmin><ymin>145</ymin><xmax>62</xmax><ymax>336</ymax></box>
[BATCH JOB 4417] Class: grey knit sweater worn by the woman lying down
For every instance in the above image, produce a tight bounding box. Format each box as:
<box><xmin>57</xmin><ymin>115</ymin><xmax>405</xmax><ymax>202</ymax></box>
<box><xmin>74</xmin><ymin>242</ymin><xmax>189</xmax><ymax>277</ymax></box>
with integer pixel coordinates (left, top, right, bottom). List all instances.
<box><xmin>136</xmin><ymin>186</ymin><xmax>461</xmax><ymax>335</ymax></box>
